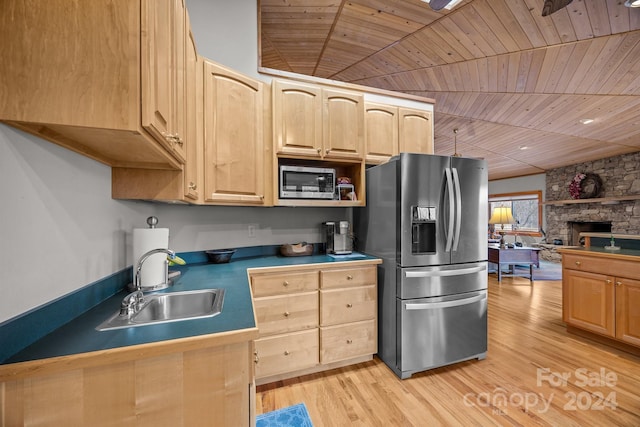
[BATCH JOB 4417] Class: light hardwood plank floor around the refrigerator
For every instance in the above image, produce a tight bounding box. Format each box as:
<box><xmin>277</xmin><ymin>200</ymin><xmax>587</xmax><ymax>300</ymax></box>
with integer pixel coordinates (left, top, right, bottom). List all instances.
<box><xmin>256</xmin><ymin>275</ymin><xmax>640</xmax><ymax>427</ymax></box>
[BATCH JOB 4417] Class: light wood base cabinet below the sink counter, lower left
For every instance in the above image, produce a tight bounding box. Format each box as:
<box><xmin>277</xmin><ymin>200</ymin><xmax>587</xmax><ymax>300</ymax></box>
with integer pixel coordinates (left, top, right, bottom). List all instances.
<box><xmin>0</xmin><ymin>331</ymin><xmax>255</xmax><ymax>427</ymax></box>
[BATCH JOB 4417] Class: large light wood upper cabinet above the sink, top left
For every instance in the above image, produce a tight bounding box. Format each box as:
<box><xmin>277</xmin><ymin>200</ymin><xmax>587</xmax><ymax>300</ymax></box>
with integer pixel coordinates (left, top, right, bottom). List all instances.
<box><xmin>0</xmin><ymin>0</ymin><xmax>188</xmax><ymax>169</ymax></box>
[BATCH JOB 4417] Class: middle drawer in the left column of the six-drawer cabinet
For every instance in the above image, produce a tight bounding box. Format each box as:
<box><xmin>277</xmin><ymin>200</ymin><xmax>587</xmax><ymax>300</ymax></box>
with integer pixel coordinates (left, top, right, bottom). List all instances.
<box><xmin>254</xmin><ymin>291</ymin><xmax>318</xmax><ymax>337</ymax></box>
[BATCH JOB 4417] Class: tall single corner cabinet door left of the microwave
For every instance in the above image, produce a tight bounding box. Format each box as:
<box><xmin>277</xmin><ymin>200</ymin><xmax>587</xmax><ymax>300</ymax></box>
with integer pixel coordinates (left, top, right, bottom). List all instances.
<box><xmin>204</xmin><ymin>61</ymin><xmax>265</xmax><ymax>205</ymax></box>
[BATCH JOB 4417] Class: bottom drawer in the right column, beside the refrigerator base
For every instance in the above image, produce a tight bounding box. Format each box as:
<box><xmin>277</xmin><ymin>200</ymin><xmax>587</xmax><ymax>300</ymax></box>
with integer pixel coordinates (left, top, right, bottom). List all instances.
<box><xmin>320</xmin><ymin>320</ymin><xmax>378</xmax><ymax>364</ymax></box>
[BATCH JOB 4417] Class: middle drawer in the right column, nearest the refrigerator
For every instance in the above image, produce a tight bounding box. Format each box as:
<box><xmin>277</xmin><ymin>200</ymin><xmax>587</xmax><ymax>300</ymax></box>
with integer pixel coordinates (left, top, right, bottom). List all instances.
<box><xmin>320</xmin><ymin>285</ymin><xmax>377</xmax><ymax>326</ymax></box>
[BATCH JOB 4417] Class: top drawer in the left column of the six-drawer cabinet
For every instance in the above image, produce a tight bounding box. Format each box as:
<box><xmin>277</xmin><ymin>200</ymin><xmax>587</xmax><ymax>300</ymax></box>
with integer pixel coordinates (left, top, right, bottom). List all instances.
<box><xmin>251</xmin><ymin>270</ymin><xmax>319</xmax><ymax>297</ymax></box>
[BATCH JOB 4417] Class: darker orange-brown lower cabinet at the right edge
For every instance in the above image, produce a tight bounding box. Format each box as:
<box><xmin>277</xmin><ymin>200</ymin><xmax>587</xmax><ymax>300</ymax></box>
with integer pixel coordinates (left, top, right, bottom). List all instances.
<box><xmin>562</xmin><ymin>250</ymin><xmax>640</xmax><ymax>347</ymax></box>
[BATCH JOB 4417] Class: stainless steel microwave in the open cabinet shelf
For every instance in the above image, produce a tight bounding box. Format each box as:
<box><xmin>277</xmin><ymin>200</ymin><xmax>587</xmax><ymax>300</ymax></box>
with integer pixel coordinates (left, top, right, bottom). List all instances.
<box><xmin>280</xmin><ymin>165</ymin><xmax>336</xmax><ymax>199</ymax></box>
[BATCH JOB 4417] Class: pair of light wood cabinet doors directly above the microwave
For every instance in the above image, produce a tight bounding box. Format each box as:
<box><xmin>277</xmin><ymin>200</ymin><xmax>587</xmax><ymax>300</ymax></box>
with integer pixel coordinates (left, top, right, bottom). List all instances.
<box><xmin>273</xmin><ymin>79</ymin><xmax>364</xmax><ymax>160</ymax></box>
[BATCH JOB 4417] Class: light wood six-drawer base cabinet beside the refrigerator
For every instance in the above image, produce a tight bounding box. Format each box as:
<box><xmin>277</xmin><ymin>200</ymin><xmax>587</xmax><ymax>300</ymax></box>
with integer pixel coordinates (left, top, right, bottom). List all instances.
<box><xmin>249</xmin><ymin>261</ymin><xmax>377</xmax><ymax>384</ymax></box>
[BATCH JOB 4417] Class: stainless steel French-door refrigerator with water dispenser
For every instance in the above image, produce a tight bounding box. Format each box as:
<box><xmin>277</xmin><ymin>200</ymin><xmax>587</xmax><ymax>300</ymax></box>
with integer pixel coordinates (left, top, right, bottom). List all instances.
<box><xmin>353</xmin><ymin>153</ymin><xmax>488</xmax><ymax>379</ymax></box>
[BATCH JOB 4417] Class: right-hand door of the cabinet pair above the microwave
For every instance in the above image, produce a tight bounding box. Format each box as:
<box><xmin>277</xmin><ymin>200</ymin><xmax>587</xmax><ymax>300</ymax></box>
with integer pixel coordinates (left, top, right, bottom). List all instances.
<box><xmin>322</xmin><ymin>89</ymin><xmax>364</xmax><ymax>160</ymax></box>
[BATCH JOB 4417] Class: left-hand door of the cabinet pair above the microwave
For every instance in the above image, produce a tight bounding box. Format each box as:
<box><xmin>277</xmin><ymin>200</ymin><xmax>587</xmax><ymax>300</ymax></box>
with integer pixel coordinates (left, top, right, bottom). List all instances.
<box><xmin>273</xmin><ymin>80</ymin><xmax>322</xmax><ymax>157</ymax></box>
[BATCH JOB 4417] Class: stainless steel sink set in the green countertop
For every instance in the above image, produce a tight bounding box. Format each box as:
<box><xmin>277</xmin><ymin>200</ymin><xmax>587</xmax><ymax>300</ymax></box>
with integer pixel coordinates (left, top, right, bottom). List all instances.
<box><xmin>96</xmin><ymin>289</ymin><xmax>224</xmax><ymax>331</ymax></box>
